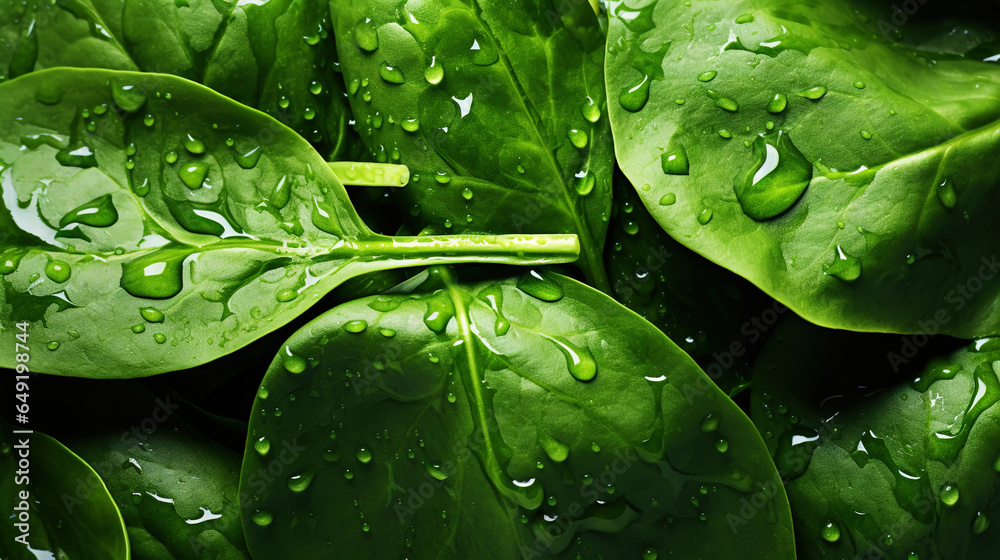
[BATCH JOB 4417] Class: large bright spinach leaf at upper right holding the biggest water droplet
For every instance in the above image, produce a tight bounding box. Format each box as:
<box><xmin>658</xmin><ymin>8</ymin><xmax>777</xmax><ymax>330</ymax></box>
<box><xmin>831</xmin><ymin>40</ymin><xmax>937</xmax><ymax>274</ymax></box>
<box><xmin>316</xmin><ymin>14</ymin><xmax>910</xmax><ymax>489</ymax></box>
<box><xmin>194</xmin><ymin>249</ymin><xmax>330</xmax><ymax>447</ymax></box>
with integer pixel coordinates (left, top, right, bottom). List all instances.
<box><xmin>607</xmin><ymin>0</ymin><xmax>1000</xmax><ymax>337</ymax></box>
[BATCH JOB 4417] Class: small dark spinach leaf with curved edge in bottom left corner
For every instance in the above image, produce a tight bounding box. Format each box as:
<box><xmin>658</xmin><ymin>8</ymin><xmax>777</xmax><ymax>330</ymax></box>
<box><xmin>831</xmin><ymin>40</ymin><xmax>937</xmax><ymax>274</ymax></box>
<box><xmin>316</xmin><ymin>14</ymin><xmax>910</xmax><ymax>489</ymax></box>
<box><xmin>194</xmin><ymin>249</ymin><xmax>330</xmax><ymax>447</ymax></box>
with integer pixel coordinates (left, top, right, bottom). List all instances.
<box><xmin>0</xmin><ymin>420</ymin><xmax>129</xmax><ymax>560</ymax></box>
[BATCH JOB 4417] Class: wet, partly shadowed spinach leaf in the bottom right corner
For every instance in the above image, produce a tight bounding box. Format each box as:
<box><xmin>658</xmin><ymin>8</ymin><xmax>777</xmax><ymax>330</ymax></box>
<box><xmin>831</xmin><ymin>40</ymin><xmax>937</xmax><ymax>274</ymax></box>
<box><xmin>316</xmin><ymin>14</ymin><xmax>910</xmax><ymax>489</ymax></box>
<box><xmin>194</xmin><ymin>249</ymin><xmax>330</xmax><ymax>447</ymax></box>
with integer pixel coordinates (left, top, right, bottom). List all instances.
<box><xmin>752</xmin><ymin>317</ymin><xmax>1000</xmax><ymax>560</ymax></box>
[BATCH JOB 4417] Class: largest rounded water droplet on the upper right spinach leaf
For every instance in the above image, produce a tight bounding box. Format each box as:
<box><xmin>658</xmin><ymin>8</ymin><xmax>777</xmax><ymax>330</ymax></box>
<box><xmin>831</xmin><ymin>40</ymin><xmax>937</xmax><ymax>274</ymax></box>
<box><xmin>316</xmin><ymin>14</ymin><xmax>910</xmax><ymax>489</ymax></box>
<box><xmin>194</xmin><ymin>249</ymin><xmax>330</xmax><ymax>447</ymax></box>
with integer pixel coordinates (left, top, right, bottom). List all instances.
<box><xmin>734</xmin><ymin>132</ymin><xmax>812</xmax><ymax>221</ymax></box>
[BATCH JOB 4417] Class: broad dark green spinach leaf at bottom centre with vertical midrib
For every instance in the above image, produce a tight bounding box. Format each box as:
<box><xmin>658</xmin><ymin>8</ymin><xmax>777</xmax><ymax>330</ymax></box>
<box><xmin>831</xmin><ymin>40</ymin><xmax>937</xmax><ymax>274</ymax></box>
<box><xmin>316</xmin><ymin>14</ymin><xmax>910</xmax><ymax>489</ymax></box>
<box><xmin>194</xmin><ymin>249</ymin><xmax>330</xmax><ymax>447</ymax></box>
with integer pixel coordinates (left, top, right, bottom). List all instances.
<box><xmin>241</xmin><ymin>267</ymin><xmax>794</xmax><ymax>560</ymax></box>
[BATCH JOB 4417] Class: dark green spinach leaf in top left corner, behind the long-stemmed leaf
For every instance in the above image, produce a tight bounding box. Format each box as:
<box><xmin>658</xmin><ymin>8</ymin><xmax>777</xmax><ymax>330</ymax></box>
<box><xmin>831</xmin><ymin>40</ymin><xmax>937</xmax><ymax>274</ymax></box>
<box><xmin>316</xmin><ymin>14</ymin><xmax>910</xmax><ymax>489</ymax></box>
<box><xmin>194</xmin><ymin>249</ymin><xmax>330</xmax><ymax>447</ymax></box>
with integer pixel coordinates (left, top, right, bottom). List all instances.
<box><xmin>0</xmin><ymin>0</ymin><xmax>352</xmax><ymax>160</ymax></box>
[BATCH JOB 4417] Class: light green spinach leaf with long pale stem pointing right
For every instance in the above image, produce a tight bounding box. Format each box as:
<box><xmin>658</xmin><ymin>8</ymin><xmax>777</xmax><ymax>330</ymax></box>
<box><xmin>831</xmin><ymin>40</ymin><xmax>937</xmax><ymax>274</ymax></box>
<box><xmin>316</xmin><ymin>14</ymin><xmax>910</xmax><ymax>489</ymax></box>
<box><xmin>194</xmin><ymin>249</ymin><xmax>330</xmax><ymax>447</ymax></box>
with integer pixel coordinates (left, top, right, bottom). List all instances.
<box><xmin>0</xmin><ymin>69</ymin><xmax>579</xmax><ymax>378</ymax></box>
